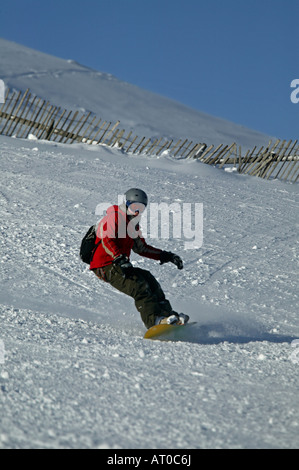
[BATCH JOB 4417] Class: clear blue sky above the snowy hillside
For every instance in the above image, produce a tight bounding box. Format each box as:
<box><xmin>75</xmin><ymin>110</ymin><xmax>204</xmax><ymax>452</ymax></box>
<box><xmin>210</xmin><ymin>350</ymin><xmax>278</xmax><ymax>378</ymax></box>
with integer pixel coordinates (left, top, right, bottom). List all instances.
<box><xmin>0</xmin><ymin>0</ymin><xmax>299</xmax><ymax>139</ymax></box>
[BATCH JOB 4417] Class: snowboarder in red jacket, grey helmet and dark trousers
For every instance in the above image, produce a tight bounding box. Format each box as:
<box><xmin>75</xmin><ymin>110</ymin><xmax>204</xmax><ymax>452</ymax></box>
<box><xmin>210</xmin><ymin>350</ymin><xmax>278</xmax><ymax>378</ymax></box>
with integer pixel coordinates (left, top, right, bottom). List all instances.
<box><xmin>90</xmin><ymin>188</ymin><xmax>189</xmax><ymax>328</ymax></box>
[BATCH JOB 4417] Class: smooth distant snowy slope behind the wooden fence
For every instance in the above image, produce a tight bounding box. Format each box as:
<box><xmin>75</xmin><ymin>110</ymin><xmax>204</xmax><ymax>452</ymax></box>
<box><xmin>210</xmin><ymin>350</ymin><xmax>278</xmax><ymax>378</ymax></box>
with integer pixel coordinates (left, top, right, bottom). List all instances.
<box><xmin>0</xmin><ymin>39</ymin><xmax>276</xmax><ymax>149</ymax></box>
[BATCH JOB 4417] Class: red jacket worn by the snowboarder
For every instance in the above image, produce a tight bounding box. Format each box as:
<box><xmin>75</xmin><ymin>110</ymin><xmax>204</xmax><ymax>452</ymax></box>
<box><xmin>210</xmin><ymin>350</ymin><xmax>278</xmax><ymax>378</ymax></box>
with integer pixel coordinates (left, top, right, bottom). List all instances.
<box><xmin>90</xmin><ymin>206</ymin><xmax>162</xmax><ymax>269</ymax></box>
